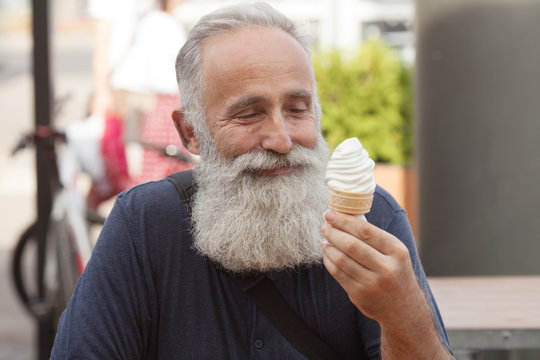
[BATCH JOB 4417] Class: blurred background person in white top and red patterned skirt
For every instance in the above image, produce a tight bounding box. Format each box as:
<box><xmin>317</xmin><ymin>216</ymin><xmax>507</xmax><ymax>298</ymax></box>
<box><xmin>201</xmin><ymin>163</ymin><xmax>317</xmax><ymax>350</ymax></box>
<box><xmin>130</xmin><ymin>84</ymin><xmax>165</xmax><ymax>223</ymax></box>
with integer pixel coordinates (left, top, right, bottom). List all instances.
<box><xmin>88</xmin><ymin>0</ymin><xmax>193</xmax><ymax>207</ymax></box>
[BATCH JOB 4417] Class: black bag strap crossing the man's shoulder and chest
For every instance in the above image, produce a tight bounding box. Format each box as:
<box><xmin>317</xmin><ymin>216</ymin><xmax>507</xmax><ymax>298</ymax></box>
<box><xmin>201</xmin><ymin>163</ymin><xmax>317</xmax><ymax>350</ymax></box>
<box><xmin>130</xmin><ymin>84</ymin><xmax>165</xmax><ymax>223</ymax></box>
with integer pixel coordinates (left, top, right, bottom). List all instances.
<box><xmin>166</xmin><ymin>170</ymin><xmax>341</xmax><ymax>360</ymax></box>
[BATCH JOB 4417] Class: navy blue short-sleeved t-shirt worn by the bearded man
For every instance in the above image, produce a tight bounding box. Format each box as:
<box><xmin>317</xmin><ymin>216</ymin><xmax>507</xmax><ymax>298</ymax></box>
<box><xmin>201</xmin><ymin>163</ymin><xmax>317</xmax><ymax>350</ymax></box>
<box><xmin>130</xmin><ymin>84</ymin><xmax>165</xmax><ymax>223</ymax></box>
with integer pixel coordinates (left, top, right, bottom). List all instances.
<box><xmin>52</xmin><ymin>180</ymin><xmax>448</xmax><ymax>359</ymax></box>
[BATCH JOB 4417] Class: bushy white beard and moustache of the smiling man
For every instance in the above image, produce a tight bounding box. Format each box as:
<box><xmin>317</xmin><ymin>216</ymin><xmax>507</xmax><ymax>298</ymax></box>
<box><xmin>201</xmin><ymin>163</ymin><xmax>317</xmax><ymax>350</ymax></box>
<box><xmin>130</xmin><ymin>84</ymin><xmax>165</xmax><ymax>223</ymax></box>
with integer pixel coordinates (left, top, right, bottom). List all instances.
<box><xmin>192</xmin><ymin>136</ymin><xmax>328</xmax><ymax>272</ymax></box>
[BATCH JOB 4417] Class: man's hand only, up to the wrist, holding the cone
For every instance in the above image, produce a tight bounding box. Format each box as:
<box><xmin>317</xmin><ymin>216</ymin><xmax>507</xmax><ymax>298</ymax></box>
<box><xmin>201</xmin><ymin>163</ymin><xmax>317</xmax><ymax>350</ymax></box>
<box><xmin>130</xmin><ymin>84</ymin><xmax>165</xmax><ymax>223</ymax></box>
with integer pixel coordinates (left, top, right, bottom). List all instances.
<box><xmin>322</xmin><ymin>211</ymin><xmax>425</xmax><ymax>325</ymax></box>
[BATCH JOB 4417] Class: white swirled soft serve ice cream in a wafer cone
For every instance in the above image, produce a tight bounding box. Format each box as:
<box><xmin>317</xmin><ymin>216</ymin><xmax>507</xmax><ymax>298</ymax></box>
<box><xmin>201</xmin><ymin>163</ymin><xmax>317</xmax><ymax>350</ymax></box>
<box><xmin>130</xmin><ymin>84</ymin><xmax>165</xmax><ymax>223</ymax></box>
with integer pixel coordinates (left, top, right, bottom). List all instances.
<box><xmin>326</xmin><ymin>138</ymin><xmax>376</xmax><ymax>215</ymax></box>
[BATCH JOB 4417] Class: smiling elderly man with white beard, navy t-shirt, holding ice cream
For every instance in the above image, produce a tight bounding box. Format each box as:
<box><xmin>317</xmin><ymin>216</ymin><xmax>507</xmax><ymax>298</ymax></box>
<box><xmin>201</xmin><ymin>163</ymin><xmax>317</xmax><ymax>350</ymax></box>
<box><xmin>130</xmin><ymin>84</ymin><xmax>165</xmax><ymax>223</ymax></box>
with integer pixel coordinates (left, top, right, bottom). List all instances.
<box><xmin>52</xmin><ymin>4</ymin><xmax>452</xmax><ymax>360</ymax></box>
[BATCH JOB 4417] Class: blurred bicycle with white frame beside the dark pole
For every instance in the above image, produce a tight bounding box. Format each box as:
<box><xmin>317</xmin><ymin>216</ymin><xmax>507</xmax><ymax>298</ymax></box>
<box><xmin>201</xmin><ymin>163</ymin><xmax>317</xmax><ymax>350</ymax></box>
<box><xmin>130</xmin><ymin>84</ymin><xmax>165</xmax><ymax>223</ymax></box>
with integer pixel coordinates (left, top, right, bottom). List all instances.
<box><xmin>11</xmin><ymin>93</ymin><xmax>105</xmax><ymax>352</ymax></box>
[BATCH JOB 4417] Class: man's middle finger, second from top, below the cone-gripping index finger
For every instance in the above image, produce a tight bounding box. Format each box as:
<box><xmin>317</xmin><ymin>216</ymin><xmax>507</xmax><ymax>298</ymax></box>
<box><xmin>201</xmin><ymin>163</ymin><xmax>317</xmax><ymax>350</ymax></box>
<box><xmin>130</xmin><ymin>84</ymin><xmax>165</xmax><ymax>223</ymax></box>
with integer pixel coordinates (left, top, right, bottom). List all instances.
<box><xmin>321</xmin><ymin>224</ymin><xmax>386</xmax><ymax>270</ymax></box>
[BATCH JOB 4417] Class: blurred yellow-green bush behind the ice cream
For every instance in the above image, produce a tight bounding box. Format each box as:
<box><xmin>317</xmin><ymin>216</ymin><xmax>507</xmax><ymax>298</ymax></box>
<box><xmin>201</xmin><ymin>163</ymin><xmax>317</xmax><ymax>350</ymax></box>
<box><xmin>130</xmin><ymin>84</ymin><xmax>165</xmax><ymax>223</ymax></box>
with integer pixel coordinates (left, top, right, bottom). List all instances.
<box><xmin>313</xmin><ymin>41</ymin><xmax>413</xmax><ymax>164</ymax></box>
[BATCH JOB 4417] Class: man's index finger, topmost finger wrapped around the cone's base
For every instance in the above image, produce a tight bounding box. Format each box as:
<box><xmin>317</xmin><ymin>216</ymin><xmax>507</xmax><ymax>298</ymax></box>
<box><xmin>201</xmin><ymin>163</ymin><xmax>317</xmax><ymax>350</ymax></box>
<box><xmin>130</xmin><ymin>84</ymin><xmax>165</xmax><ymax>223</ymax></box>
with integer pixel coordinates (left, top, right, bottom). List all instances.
<box><xmin>325</xmin><ymin>211</ymin><xmax>401</xmax><ymax>255</ymax></box>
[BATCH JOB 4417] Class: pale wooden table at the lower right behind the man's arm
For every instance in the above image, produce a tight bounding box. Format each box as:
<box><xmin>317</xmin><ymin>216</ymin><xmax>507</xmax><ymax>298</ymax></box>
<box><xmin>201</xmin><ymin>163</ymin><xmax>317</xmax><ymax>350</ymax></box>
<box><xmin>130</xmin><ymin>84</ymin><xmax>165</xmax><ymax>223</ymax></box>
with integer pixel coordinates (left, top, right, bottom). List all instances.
<box><xmin>428</xmin><ymin>276</ymin><xmax>540</xmax><ymax>359</ymax></box>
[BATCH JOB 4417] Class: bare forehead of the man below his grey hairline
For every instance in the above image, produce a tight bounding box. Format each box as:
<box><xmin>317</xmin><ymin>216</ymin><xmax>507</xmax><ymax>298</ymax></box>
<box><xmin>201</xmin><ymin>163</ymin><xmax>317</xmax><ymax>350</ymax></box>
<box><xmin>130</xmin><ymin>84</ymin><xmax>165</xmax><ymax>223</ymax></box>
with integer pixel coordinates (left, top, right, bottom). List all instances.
<box><xmin>201</xmin><ymin>27</ymin><xmax>313</xmax><ymax>98</ymax></box>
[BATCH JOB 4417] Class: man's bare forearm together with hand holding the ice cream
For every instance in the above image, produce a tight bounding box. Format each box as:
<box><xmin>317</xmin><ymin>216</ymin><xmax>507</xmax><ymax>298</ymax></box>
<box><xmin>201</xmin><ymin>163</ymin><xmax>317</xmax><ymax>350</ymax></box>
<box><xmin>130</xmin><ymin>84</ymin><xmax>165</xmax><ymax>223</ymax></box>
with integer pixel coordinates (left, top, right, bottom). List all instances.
<box><xmin>321</xmin><ymin>211</ymin><xmax>451</xmax><ymax>360</ymax></box>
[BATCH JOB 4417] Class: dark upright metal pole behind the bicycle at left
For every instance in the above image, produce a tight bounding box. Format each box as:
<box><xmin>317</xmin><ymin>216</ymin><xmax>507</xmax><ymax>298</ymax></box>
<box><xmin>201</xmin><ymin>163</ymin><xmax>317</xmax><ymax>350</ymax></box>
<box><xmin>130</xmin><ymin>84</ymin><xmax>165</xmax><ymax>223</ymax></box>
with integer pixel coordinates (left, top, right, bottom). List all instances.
<box><xmin>32</xmin><ymin>0</ymin><xmax>55</xmax><ymax>360</ymax></box>
